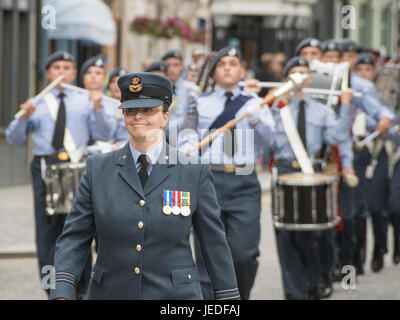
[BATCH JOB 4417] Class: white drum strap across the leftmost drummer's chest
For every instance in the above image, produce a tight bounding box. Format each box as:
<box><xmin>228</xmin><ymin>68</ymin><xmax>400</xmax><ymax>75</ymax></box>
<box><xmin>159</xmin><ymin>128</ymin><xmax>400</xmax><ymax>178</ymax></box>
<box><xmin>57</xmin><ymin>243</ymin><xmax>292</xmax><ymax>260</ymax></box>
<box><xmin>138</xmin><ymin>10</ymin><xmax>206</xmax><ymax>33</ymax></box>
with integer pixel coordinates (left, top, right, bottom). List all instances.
<box><xmin>43</xmin><ymin>92</ymin><xmax>86</xmax><ymax>162</ymax></box>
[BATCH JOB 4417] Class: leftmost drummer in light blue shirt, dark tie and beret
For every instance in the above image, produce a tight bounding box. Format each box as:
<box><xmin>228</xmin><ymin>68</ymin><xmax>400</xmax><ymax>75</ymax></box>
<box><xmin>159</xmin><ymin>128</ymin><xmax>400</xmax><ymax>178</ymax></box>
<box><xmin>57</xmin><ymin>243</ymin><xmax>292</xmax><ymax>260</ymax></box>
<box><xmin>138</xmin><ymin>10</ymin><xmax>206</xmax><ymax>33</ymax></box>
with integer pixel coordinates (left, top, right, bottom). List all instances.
<box><xmin>6</xmin><ymin>51</ymin><xmax>111</xmax><ymax>293</ymax></box>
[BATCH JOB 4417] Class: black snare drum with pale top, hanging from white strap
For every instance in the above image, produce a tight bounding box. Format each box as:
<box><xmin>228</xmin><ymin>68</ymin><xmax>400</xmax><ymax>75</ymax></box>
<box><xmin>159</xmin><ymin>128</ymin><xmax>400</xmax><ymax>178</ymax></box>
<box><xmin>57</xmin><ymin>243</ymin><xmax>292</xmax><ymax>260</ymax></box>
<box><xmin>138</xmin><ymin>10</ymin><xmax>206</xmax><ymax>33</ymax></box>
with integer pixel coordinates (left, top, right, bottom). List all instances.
<box><xmin>272</xmin><ymin>173</ymin><xmax>340</xmax><ymax>231</ymax></box>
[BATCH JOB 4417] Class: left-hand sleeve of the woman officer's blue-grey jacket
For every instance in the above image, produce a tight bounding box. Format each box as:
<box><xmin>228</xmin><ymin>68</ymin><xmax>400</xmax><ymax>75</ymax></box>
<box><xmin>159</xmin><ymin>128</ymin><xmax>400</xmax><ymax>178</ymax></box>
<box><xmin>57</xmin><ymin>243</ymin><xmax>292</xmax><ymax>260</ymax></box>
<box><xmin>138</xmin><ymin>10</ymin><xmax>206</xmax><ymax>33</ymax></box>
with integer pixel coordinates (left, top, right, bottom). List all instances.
<box><xmin>50</xmin><ymin>159</ymin><xmax>94</xmax><ymax>300</ymax></box>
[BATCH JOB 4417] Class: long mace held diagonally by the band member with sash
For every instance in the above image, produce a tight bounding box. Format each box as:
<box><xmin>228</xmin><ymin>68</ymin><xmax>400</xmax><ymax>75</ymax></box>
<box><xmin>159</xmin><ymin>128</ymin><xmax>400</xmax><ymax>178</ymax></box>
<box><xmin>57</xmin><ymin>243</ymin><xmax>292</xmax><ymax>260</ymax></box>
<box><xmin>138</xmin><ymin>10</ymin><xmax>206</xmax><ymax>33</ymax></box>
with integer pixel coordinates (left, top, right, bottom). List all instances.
<box><xmin>186</xmin><ymin>74</ymin><xmax>308</xmax><ymax>154</ymax></box>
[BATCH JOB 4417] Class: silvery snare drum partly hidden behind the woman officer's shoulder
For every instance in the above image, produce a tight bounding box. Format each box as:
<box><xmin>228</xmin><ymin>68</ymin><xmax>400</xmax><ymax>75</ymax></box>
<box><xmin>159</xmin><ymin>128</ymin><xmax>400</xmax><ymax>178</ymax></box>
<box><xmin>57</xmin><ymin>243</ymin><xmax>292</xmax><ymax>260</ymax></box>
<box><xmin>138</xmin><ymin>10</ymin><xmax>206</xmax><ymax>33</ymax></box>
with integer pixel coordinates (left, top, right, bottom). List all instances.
<box><xmin>44</xmin><ymin>162</ymin><xmax>86</xmax><ymax>216</ymax></box>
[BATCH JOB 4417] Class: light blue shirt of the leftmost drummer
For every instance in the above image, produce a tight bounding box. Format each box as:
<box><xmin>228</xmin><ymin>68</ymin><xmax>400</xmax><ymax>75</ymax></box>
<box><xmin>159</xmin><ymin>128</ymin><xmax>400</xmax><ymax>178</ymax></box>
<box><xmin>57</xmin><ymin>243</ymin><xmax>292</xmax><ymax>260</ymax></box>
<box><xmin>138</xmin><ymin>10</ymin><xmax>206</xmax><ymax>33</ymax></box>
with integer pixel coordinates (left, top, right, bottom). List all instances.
<box><xmin>6</xmin><ymin>89</ymin><xmax>113</xmax><ymax>156</ymax></box>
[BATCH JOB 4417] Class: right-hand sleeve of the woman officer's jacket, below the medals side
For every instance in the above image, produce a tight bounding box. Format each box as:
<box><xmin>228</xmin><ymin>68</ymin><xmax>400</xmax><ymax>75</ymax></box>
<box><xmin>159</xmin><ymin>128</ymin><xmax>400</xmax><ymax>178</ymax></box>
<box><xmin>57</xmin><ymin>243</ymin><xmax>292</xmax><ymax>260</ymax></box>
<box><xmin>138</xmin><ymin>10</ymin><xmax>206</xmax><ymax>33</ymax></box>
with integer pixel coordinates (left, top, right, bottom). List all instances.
<box><xmin>193</xmin><ymin>165</ymin><xmax>240</xmax><ymax>300</ymax></box>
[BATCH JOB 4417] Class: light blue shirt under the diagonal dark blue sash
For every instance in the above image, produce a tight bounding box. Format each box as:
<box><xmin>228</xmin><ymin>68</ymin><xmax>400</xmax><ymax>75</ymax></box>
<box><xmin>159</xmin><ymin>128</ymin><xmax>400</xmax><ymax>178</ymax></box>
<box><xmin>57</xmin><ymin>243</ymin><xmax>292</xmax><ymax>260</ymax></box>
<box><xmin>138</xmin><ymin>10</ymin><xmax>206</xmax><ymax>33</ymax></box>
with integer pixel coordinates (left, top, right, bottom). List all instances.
<box><xmin>178</xmin><ymin>86</ymin><xmax>275</xmax><ymax>165</ymax></box>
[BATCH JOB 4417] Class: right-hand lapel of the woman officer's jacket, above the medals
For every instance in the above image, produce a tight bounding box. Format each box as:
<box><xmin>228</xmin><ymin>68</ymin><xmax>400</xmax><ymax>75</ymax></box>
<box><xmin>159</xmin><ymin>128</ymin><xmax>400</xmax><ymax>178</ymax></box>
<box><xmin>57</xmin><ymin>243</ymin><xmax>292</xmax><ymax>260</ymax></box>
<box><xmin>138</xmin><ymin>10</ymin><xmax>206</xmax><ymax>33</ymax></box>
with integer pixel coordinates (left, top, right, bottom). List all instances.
<box><xmin>144</xmin><ymin>143</ymin><xmax>174</xmax><ymax>196</ymax></box>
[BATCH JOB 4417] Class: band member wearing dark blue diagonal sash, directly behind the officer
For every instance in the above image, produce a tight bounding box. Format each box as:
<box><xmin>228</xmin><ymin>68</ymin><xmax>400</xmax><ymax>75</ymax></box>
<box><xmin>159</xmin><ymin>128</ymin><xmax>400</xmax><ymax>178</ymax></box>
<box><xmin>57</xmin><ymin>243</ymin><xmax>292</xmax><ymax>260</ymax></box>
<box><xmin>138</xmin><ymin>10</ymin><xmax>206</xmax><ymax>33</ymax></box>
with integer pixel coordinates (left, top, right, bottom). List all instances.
<box><xmin>179</xmin><ymin>47</ymin><xmax>274</xmax><ymax>300</ymax></box>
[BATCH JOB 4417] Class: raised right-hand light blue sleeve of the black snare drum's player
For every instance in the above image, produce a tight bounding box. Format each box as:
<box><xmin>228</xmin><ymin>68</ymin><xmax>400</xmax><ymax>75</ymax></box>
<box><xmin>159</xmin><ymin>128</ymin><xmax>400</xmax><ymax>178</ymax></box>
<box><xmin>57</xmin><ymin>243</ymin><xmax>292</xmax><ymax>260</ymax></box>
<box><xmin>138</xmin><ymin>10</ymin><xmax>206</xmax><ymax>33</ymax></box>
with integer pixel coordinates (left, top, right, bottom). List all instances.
<box><xmin>324</xmin><ymin>104</ymin><xmax>352</xmax><ymax>145</ymax></box>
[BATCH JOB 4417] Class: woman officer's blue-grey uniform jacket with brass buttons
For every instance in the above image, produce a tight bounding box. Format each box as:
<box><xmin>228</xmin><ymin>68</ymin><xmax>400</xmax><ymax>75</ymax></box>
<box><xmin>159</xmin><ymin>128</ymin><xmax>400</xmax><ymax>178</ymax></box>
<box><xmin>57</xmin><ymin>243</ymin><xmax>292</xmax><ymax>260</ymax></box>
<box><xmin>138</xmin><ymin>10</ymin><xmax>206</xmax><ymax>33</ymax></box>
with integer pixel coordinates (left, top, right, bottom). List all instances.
<box><xmin>50</xmin><ymin>143</ymin><xmax>239</xmax><ymax>300</ymax></box>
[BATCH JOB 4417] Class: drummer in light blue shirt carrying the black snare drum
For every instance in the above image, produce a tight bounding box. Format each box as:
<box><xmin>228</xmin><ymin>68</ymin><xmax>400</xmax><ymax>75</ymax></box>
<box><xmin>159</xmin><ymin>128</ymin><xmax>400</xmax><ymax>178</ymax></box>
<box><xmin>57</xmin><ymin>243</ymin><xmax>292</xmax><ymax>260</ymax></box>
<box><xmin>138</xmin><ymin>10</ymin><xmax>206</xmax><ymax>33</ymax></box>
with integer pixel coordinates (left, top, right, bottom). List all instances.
<box><xmin>271</xmin><ymin>57</ymin><xmax>352</xmax><ymax>299</ymax></box>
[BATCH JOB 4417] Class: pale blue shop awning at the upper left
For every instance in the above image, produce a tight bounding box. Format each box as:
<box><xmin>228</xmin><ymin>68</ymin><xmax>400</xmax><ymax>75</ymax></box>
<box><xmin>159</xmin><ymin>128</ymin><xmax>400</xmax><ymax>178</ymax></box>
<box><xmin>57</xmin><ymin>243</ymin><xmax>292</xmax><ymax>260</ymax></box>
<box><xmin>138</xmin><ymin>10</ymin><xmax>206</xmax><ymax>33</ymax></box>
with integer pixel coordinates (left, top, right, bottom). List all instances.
<box><xmin>42</xmin><ymin>0</ymin><xmax>116</xmax><ymax>46</ymax></box>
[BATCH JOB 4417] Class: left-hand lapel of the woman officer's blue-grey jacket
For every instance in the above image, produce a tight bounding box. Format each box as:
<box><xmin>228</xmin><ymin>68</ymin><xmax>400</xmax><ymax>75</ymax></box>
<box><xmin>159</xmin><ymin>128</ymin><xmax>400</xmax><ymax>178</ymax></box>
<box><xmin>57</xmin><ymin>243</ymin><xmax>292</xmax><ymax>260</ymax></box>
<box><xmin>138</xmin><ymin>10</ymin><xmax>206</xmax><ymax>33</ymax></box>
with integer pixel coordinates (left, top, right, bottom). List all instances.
<box><xmin>117</xmin><ymin>142</ymin><xmax>144</xmax><ymax>198</ymax></box>
